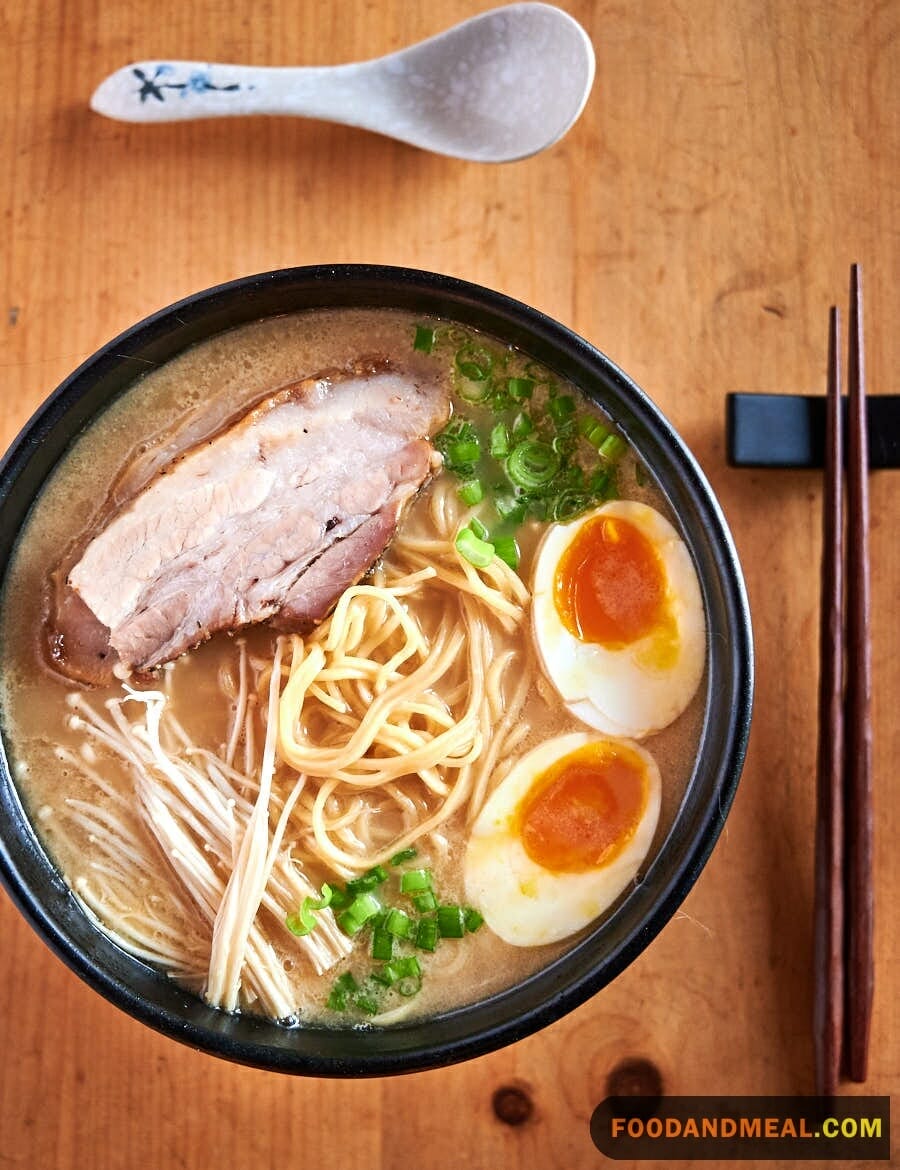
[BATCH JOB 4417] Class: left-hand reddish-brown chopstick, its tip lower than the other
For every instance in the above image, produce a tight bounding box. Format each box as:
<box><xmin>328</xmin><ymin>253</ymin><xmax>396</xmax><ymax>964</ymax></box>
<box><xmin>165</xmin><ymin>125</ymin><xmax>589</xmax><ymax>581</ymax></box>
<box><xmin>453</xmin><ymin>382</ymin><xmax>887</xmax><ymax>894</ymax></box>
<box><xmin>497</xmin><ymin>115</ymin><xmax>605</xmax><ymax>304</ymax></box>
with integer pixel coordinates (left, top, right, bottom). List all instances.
<box><xmin>813</xmin><ymin>307</ymin><xmax>844</xmax><ymax>1096</ymax></box>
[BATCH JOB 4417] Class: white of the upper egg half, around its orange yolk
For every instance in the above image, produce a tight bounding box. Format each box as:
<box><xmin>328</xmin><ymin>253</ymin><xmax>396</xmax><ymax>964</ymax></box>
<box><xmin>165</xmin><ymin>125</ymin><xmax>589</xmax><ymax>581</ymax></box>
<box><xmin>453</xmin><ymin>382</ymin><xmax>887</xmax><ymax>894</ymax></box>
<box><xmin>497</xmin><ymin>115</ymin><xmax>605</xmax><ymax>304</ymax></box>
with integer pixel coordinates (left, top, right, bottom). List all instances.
<box><xmin>531</xmin><ymin>500</ymin><xmax>706</xmax><ymax>739</ymax></box>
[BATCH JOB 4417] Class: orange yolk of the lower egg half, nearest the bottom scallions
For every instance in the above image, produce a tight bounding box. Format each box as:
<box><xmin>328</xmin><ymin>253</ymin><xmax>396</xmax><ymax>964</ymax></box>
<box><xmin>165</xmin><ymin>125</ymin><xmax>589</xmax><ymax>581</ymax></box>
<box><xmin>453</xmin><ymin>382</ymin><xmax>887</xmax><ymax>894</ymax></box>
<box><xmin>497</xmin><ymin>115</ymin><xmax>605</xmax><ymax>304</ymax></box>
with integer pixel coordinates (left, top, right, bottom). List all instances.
<box><xmin>517</xmin><ymin>741</ymin><xmax>648</xmax><ymax>873</ymax></box>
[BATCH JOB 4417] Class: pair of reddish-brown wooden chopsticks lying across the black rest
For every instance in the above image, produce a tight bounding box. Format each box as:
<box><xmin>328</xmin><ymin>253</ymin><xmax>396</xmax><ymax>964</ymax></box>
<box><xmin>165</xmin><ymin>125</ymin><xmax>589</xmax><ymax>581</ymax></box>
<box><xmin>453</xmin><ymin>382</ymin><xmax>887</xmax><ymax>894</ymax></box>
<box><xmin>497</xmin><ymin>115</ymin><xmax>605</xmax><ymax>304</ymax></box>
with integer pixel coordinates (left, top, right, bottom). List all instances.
<box><xmin>813</xmin><ymin>264</ymin><xmax>873</xmax><ymax>1096</ymax></box>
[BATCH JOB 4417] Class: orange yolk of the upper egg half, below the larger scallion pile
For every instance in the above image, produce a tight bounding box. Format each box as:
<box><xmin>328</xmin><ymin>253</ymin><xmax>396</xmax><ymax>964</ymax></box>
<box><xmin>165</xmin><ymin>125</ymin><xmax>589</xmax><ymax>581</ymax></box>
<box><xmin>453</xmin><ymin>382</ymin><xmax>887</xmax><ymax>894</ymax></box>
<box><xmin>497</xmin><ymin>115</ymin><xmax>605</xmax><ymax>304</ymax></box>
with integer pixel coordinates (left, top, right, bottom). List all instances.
<box><xmin>554</xmin><ymin>516</ymin><xmax>668</xmax><ymax>649</ymax></box>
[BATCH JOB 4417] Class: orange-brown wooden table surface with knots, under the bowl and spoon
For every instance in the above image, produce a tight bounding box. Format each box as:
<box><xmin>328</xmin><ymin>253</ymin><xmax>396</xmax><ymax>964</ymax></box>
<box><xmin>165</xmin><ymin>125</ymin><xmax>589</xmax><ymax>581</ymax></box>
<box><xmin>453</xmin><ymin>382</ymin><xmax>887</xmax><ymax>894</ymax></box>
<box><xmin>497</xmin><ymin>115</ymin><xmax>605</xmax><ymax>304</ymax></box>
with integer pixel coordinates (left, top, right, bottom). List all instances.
<box><xmin>0</xmin><ymin>0</ymin><xmax>900</xmax><ymax>1170</ymax></box>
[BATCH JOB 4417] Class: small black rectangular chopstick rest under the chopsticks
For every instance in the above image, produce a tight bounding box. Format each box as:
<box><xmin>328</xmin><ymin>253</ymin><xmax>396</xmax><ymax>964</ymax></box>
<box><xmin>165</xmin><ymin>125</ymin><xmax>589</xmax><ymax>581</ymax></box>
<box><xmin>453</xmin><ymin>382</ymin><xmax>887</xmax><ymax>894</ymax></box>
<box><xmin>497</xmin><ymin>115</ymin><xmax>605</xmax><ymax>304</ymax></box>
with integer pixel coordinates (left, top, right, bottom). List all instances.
<box><xmin>726</xmin><ymin>394</ymin><xmax>900</xmax><ymax>470</ymax></box>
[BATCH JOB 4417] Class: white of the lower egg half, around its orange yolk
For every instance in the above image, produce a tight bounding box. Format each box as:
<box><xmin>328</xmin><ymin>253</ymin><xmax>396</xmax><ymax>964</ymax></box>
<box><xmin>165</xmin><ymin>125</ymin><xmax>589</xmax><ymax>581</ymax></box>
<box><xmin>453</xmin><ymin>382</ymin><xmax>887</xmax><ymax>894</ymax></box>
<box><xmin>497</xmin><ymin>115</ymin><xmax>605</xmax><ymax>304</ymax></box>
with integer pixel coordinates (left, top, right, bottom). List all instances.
<box><xmin>463</xmin><ymin>731</ymin><xmax>661</xmax><ymax>947</ymax></box>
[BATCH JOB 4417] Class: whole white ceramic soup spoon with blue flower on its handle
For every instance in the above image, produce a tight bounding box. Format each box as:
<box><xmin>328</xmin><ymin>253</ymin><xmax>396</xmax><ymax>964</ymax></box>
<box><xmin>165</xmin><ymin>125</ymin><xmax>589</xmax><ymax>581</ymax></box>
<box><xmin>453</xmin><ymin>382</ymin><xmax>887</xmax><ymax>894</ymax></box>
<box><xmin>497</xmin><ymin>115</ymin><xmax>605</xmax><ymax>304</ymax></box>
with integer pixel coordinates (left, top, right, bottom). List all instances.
<box><xmin>90</xmin><ymin>4</ymin><xmax>595</xmax><ymax>163</ymax></box>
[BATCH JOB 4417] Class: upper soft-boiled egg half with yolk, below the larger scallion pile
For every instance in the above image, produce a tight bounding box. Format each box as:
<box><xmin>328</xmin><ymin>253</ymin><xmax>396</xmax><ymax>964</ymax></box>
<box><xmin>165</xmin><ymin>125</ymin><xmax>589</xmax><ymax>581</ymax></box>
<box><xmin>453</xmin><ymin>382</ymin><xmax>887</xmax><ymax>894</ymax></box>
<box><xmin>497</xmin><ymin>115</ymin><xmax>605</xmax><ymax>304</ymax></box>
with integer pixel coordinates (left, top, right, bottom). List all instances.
<box><xmin>531</xmin><ymin>500</ymin><xmax>706</xmax><ymax>739</ymax></box>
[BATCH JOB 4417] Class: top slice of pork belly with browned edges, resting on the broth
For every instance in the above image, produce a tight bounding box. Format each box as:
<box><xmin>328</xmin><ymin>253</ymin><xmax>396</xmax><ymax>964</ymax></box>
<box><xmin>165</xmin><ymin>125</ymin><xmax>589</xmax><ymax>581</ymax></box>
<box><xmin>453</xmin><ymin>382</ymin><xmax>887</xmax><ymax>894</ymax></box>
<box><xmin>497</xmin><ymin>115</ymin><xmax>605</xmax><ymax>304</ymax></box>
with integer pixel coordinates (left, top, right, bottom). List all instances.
<box><xmin>61</xmin><ymin>364</ymin><xmax>449</xmax><ymax>674</ymax></box>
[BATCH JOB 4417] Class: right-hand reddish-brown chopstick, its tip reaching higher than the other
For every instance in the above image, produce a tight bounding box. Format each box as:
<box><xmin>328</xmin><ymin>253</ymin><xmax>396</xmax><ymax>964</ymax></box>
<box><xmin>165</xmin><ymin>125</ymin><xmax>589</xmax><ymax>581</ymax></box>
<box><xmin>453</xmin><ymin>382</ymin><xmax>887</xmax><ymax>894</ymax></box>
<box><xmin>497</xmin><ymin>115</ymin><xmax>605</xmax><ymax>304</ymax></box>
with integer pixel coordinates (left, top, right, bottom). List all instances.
<box><xmin>844</xmin><ymin>264</ymin><xmax>874</xmax><ymax>1081</ymax></box>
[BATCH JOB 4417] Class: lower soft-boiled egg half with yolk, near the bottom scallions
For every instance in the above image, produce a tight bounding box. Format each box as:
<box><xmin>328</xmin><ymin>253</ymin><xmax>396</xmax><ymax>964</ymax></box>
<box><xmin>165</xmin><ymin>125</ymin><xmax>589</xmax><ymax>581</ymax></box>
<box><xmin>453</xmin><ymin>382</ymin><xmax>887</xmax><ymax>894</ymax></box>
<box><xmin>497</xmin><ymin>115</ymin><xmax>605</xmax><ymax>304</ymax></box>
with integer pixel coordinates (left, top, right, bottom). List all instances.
<box><xmin>463</xmin><ymin>731</ymin><xmax>661</xmax><ymax>947</ymax></box>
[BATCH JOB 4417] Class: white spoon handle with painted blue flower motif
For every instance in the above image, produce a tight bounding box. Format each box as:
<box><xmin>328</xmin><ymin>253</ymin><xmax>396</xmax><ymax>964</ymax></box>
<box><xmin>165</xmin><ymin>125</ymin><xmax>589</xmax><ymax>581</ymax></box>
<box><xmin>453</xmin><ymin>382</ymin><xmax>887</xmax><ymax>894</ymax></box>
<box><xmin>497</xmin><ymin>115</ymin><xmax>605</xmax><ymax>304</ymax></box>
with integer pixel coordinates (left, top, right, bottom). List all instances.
<box><xmin>90</xmin><ymin>61</ymin><xmax>380</xmax><ymax>126</ymax></box>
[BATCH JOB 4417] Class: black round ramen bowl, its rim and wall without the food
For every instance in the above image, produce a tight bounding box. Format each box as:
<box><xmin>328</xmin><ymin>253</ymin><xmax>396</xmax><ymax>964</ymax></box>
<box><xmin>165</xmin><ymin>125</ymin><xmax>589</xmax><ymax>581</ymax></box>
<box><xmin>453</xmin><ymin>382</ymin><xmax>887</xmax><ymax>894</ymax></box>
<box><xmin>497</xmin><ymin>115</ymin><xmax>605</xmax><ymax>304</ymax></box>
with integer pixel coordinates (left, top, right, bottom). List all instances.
<box><xmin>0</xmin><ymin>264</ymin><xmax>753</xmax><ymax>1076</ymax></box>
